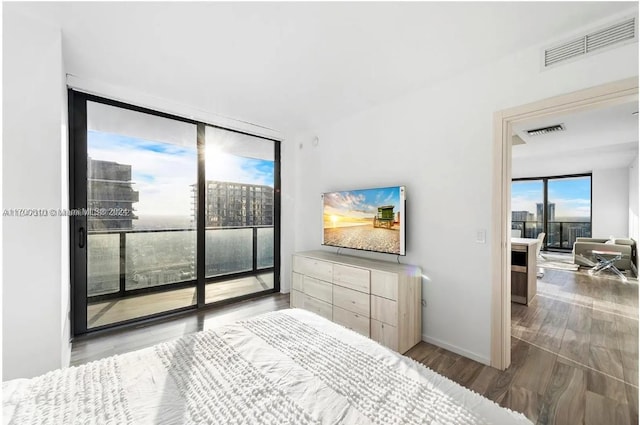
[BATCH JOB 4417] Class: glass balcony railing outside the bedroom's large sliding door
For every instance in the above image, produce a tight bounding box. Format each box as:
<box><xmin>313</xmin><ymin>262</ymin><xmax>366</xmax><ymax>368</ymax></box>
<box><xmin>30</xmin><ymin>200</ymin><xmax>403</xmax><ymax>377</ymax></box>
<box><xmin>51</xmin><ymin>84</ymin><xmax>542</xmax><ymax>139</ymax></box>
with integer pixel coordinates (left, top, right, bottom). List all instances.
<box><xmin>87</xmin><ymin>226</ymin><xmax>273</xmax><ymax>300</ymax></box>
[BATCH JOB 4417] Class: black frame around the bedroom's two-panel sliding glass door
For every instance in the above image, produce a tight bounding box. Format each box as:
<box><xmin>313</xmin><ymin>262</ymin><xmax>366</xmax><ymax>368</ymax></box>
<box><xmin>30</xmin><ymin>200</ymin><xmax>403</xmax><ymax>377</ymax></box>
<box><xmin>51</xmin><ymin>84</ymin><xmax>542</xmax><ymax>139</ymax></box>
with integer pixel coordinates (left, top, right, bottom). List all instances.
<box><xmin>68</xmin><ymin>88</ymin><xmax>281</xmax><ymax>336</ymax></box>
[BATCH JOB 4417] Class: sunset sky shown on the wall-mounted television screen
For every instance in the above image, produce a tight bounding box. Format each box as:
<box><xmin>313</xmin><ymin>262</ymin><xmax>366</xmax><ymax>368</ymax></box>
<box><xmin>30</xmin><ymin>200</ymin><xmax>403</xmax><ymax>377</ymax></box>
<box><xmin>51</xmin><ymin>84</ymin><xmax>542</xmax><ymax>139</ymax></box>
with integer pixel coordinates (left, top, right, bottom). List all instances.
<box><xmin>324</xmin><ymin>186</ymin><xmax>400</xmax><ymax>218</ymax></box>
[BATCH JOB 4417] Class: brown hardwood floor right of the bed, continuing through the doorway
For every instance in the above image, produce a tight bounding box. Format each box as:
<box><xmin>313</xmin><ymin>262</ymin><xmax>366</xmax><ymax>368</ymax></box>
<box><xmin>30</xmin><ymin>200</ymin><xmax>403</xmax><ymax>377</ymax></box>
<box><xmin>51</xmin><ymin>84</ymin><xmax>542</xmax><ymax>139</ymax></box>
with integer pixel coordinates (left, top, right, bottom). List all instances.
<box><xmin>407</xmin><ymin>269</ymin><xmax>638</xmax><ymax>425</ymax></box>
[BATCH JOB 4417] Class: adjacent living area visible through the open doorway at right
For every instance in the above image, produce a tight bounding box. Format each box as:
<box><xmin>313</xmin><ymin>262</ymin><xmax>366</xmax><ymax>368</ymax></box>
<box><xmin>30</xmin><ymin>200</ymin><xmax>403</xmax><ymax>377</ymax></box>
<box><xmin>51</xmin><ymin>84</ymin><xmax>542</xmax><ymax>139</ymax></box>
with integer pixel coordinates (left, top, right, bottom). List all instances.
<box><xmin>511</xmin><ymin>102</ymin><xmax>638</xmax><ymax>423</ymax></box>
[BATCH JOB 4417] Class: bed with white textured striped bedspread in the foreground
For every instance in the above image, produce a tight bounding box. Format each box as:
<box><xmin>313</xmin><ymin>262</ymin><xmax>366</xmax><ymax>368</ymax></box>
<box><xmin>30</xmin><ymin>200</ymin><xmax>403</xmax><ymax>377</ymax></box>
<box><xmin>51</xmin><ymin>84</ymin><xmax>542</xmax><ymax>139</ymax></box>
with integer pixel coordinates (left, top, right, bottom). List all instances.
<box><xmin>3</xmin><ymin>309</ymin><xmax>531</xmax><ymax>425</ymax></box>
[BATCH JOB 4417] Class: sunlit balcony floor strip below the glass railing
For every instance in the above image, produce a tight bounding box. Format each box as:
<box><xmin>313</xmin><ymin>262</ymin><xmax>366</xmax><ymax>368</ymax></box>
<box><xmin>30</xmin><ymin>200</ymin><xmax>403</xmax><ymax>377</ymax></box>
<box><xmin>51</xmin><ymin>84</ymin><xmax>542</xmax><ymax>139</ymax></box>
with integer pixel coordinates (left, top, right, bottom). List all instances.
<box><xmin>87</xmin><ymin>272</ymin><xmax>273</xmax><ymax>329</ymax></box>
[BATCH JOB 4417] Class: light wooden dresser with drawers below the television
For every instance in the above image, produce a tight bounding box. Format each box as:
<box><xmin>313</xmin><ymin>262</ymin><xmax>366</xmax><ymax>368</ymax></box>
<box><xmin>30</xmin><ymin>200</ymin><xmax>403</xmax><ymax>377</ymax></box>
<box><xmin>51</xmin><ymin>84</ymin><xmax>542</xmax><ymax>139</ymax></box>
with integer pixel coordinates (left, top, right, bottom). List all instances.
<box><xmin>291</xmin><ymin>251</ymin><xmax>422</xmax><ymax>353</ymax></box>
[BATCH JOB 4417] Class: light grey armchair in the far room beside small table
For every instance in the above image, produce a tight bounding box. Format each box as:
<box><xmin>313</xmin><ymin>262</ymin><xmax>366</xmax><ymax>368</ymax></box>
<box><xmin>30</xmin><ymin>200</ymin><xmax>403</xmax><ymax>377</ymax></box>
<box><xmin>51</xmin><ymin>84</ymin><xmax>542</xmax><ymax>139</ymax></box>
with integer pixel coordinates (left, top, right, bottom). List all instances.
<box><xmin>573</xmin><ymin>238</ymin><xmax>636</xmax><ymax>270</ymax></box>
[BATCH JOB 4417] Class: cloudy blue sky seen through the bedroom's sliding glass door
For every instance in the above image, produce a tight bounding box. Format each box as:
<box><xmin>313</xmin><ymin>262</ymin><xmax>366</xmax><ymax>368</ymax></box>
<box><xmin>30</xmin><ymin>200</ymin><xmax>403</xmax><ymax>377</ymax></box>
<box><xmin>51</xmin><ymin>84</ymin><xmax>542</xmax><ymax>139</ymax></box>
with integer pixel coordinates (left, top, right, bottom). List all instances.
<box><xmin>87</xmin><ymin>130</ymin><xmax>274</xmax><ymax>218</ymax></box>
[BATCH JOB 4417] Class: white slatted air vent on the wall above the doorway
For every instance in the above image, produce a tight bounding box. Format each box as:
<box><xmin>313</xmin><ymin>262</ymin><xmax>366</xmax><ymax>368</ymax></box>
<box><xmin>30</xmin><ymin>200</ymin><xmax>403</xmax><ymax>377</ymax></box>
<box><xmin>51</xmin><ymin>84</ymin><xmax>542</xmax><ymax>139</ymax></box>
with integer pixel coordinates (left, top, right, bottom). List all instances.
<box><xmin>544</xmin><ymin>17</ymin><xmax>638</xmax><ymax>68</ymax></box>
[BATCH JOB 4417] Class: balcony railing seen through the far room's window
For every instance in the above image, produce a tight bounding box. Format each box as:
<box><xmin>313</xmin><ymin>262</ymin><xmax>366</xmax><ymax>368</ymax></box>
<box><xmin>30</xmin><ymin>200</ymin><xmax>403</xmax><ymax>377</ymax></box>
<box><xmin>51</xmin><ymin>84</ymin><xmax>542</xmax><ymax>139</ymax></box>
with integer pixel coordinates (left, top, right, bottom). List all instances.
<box><xmin>511</xmin><ymin>221</ymin><xmax>591</xmax><ymax>250</ymax></box>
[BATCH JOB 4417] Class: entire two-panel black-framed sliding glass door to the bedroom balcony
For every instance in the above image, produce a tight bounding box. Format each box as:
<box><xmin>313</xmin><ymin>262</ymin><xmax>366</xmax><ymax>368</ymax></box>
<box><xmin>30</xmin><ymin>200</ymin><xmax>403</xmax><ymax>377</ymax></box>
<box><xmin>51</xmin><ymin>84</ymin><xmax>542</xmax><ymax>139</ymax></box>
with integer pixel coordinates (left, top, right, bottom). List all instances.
<box><xmin>69</xmin><ymin>91</ymin><xmax>279</xmax><ymax>334</ymax></box>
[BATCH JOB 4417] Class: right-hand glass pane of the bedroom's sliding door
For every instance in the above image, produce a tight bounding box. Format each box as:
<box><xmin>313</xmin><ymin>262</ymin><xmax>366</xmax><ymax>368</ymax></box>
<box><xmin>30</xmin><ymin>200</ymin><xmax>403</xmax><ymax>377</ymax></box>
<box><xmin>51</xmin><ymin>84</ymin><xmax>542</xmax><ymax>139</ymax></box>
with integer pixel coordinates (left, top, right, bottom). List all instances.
<box><xmin>204</xmin><ymin>126</ymin><xmax>276</xmax><ymax>303</ymax></box>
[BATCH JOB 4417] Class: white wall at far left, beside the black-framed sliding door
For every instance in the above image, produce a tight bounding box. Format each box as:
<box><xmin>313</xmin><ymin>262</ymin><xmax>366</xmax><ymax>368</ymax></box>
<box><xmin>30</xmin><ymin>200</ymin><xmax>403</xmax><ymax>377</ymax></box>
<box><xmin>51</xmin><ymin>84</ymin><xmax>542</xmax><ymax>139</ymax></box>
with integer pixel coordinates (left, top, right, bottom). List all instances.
<box><xmin>2</xmin><ymin>4</ymin><xmax>70</xmax><ymax>380</ymax></box>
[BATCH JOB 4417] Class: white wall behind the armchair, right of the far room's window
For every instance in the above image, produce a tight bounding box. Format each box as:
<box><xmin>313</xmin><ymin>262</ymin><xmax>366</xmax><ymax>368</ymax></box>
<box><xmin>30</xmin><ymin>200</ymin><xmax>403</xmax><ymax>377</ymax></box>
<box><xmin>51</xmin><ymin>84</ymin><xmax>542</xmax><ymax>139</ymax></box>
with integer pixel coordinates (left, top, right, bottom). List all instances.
<box><xmin>591</xmin><ymin>167</ymin><xmax>629</xmax><ymax>238</ymax></box>
